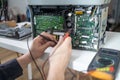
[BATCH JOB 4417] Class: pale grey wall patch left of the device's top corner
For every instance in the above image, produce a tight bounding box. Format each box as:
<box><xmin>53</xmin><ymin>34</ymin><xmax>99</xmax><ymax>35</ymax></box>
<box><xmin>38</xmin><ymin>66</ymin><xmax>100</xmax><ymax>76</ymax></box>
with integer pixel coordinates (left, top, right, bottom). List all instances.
<box><xmin>8</xmin><ymin>0</ymin><xmax>27</xmax><ymax>14</ymax></box>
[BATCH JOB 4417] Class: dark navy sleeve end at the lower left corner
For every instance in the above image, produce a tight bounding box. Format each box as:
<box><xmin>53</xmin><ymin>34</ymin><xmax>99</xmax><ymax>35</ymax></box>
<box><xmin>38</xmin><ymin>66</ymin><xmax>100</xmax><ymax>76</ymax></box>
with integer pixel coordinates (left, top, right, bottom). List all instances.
<box><xmin>0</xmin><ymin>59</ymin><xmax>23</xmax><ymax>80</ymax></box>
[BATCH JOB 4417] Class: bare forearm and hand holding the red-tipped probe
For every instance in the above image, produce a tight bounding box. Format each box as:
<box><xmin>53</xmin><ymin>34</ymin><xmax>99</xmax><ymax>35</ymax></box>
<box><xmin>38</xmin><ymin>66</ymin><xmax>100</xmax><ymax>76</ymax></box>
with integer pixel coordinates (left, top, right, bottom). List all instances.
<box><xmin>47</xmin><ymin>37</ymin><xmax>72</xmax><ymax>80</ymax></box>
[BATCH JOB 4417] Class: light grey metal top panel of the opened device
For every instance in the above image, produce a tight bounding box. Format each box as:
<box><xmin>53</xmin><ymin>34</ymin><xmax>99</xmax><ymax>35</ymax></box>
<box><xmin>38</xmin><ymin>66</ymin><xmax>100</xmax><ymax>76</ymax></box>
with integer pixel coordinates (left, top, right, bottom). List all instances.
<box><xmin>28</xmin><ymin>0</ymin><xmax>111</xmax><ymax>5</ymax></box>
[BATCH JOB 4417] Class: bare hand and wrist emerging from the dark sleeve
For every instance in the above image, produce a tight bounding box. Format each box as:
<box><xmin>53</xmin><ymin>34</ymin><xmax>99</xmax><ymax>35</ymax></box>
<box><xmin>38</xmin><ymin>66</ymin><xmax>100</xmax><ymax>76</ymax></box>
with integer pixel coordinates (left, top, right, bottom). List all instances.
<box><xmin>17</xmin><ymin>32</ymin><xmax>57</xmax><ymax>69</ymax></box>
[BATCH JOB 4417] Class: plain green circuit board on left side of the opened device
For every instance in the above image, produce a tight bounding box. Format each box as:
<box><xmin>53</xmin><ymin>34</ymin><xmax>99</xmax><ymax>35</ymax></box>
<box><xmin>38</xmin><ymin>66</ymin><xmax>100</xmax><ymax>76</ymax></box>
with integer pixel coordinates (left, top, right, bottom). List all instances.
<box><xmin>34</xmin><ymin>15</ymin><xmax>64</xmax><ymax>33</ymax></box>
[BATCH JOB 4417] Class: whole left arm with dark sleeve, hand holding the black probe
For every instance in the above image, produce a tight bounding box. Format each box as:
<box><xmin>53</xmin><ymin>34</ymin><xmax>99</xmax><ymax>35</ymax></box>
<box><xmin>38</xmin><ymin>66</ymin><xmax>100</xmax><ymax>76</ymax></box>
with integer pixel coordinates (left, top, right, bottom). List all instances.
<box><xmin>0</xmin><ymin>32</ymin><xmax>56</xmax><ymax>80</ymax></box>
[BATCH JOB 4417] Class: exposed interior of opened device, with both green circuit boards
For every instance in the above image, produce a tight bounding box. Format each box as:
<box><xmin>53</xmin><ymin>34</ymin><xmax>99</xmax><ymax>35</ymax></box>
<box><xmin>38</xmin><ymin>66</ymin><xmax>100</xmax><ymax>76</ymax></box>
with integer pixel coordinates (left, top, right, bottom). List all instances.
<box><xmin>30</xmin><ymin>5</ymin><xmax>107</xmax><ymax>50</ymax></box>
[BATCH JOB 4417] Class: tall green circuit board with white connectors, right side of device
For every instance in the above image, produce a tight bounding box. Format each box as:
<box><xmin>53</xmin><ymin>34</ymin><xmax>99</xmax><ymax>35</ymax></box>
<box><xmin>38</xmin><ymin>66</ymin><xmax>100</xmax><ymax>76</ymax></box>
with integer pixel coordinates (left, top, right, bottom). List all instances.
<box><xmin>72</xmin><ymin>14</ymin><xmax>98</xmax><ymax>49</ymax></box>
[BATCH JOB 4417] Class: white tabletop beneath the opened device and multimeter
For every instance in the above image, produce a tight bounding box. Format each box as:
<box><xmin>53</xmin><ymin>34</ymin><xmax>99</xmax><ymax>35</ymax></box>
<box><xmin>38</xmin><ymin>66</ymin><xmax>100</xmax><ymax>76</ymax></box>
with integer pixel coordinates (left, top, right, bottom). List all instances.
<box><xmin>0</xmin><ymin>29</ymin><xmax>120</xmax><ymax>80</ymax></box>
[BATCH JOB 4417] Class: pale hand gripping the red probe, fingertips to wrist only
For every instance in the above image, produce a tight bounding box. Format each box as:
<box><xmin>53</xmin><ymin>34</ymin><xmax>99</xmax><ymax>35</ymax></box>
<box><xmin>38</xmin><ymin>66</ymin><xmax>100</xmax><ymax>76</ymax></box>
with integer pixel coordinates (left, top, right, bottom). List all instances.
<box><xmin>49</xmin><ymin>37</ymin><xmax>72</xmax><ymax>72</ymax></box>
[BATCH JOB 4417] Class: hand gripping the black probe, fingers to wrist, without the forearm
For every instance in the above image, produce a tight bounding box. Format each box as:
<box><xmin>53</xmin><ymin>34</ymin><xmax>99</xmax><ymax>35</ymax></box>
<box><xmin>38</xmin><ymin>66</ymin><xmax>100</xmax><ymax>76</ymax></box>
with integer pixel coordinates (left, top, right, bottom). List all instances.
<box><xmin>30</xmin><ymin>32</ymin><xmax>57</xmax><ymax>59</ymax></box>
